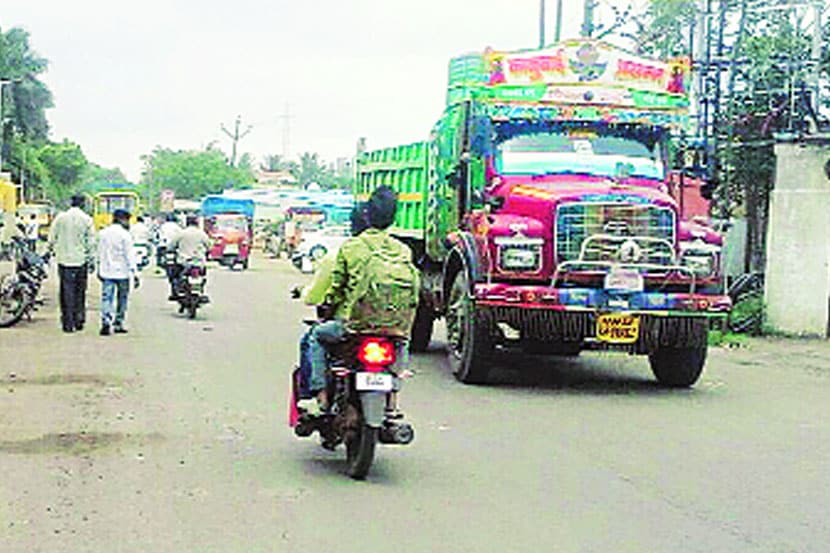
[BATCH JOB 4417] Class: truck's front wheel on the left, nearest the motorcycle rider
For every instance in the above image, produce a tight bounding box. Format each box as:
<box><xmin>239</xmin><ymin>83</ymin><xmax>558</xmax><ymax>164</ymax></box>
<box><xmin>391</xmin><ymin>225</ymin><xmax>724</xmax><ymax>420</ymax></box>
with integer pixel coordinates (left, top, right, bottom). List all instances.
<box><xmin>447</xmin><ymin>270</ymin><xmax>493</xmax><ymax>384</ymax></box>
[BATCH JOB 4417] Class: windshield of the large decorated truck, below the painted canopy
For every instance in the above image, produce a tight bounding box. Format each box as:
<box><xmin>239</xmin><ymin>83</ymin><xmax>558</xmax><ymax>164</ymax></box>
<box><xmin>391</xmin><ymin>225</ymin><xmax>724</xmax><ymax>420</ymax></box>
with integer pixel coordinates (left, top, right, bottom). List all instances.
<box><xmin>496</xmin><ymin>131</ymin><xmax>663</xmax><ymax>179</ymax></box>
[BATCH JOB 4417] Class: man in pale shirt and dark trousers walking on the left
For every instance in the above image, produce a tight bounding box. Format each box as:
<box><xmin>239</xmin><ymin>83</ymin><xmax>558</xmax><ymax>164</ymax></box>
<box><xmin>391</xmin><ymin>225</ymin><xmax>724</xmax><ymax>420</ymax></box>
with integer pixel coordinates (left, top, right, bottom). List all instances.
<box><xmin>49</xmin><ymin>195</ymin><xmax>95</xmax><ymax>332</ymax></box>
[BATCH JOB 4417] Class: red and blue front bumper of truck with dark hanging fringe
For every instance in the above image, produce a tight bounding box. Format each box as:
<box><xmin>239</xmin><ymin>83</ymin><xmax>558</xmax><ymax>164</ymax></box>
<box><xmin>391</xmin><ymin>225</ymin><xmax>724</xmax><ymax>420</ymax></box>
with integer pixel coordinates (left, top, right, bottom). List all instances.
<box><xmin>474</xmin><ymin>284</ymin><xmax>731</xmax><ymax>353</ymax></box>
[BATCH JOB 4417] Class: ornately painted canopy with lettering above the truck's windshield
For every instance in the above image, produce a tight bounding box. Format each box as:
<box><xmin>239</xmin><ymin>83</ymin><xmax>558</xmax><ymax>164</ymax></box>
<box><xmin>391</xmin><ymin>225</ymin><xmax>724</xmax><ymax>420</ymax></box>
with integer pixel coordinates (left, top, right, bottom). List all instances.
<box><xmin>447</xmin><ymin>40</ymin><xmax>690</xmax><ymax>127</ymax></box>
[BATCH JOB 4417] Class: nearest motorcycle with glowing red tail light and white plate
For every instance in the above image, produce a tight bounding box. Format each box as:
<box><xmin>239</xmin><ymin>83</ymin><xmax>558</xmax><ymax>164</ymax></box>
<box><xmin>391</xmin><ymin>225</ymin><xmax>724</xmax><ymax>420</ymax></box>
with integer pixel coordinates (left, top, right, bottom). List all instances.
<box><xmin>289</xmin><ymin>322</ymin><xmax>415</xmax><ymax>480</ymax></box>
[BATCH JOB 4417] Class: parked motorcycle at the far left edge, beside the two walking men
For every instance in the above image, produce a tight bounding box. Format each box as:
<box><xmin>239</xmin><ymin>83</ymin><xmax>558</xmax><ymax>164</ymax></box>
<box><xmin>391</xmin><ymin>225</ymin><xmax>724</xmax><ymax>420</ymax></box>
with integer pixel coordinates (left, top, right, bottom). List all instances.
<box><xmin>0</xmin><ymin>236</ymin><xmax>50</xmax><ymax>328</ymax></box>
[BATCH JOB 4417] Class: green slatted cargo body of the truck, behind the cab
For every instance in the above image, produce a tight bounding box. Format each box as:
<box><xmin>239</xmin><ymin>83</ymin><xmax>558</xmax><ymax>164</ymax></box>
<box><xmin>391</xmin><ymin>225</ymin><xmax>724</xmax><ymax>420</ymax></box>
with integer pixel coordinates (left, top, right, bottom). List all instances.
<box><xmin>355</xmin><ymin>142</ymin><xmax>429</xmax><ymax>239</ymax></box>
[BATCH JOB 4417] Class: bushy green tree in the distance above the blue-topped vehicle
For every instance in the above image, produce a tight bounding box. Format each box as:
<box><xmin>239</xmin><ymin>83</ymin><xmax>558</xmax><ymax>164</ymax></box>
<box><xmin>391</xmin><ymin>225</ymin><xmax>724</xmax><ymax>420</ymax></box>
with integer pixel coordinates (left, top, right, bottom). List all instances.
<box><xmin>141</xmin><ymin>147</ymin><xmax>254</xmax><ymax>206</ymax></box>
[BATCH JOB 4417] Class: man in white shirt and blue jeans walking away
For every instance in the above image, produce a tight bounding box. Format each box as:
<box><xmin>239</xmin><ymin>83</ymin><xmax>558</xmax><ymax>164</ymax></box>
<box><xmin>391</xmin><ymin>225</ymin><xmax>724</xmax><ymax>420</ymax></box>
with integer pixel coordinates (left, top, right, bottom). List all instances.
<box><xmin>98</xmin><ymin>209</ymin><xmax>139</xmax><ymax>336</ymax></box>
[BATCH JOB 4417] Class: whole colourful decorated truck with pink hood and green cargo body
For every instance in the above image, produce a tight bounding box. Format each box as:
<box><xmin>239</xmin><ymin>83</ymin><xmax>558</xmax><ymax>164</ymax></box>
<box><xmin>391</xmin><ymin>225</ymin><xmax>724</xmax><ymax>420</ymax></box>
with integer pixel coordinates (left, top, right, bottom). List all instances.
<box><xmin>357</xmin><ymin>40</ymin><xmax>729</xmax><ymax>386</ymax></box>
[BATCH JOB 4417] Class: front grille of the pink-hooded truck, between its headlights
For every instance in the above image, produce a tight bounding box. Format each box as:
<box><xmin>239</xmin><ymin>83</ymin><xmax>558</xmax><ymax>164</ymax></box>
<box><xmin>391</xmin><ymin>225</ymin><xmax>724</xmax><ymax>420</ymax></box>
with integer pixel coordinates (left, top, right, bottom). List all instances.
<box><xmin>556</xmin><ymin>202</ymin><xmax>675</xmax><ymax>265</ymax></box>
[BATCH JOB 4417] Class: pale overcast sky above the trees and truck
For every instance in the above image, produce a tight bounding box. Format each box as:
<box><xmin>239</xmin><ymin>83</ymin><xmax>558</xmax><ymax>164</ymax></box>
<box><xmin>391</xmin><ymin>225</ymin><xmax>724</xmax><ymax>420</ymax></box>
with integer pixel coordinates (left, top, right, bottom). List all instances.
<box><xmin>0</xmin><ymin>0</ymin><xmax>636</xmax><ymax>179</ymax></box>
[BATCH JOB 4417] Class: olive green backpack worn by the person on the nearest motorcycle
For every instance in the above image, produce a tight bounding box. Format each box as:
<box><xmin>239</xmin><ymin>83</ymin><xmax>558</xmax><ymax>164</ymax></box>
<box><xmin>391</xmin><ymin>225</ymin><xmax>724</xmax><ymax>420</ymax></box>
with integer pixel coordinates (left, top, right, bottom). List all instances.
<box><xmin>349</xmin><ymin>237</ymin><xmax>420</xmax><ymax>338</ymax></box>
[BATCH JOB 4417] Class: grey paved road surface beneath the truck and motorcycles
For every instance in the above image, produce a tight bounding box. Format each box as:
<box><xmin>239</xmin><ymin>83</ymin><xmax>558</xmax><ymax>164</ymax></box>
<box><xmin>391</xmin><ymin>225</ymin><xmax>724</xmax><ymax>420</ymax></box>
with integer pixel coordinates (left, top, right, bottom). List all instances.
<box><xmin>0</xmin><ymin>260</ymin><xmax>830</xmax><ymax>553</ymax></box>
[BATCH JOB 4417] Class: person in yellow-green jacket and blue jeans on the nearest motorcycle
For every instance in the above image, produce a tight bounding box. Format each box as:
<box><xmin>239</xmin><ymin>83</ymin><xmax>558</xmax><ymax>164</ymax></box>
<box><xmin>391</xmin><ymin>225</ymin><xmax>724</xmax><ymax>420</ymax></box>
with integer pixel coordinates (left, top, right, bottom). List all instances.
<box><xmin>298</xmin><ymin>186</ymin><xmax>420</xmax><ymax>415</ymax></box>
